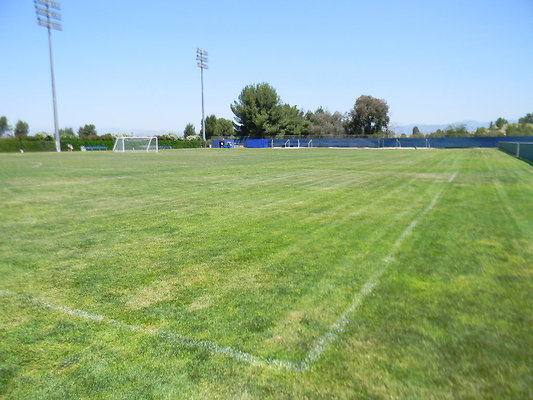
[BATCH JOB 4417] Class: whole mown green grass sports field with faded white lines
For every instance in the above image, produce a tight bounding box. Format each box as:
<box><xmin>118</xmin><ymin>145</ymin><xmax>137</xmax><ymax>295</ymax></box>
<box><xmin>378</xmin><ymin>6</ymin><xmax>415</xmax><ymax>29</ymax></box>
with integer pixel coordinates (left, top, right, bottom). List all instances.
<box><xmin>0</xmin><ymin>149</ymin><xmax>533</xmax><ymax>399</ymax></box>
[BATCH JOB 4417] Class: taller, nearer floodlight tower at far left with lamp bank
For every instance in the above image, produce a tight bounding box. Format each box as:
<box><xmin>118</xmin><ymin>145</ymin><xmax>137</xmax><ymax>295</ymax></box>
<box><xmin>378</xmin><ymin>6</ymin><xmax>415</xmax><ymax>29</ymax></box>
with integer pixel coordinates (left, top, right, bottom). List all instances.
<box><xmin>33</xmin><ymin>0</ymin><xmax>61</xmax><ymax>152</ymax></box>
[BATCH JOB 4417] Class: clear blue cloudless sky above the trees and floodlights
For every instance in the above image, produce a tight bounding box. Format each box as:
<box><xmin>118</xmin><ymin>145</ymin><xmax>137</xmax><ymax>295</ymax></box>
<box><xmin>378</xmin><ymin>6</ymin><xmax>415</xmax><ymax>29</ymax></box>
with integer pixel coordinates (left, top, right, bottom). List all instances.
<box><xmin>0</xmin><ymin>0</ymin><xmax>533</xmax><ymax>134</ymax></box>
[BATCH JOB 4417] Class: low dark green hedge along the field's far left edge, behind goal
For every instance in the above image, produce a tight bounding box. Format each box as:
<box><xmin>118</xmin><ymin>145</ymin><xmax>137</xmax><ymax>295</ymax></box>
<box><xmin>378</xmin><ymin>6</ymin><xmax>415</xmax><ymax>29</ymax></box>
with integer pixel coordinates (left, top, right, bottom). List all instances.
<box><xmin>0</xmin><ymin>136</ymin><xmax>204</xmax><ymax>152</ymax></box>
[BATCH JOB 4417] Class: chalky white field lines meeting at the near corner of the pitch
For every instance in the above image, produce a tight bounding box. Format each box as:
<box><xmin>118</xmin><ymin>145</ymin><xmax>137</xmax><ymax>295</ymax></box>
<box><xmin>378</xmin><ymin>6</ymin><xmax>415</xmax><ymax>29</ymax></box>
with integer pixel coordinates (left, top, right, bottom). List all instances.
<box><xmin>0</xmin><ymin>173</ymin><xmax>457</xmax><ymax>372</ymax></box>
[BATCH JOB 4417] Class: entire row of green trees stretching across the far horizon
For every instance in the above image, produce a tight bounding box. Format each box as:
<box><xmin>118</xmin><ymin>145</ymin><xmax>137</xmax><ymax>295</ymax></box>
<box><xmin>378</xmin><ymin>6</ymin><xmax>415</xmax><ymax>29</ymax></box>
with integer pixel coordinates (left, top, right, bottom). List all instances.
<box><xmin>0</xmin><ymin>83</ymin><xmax>533</xmax><ymax>140</ymax></box>
